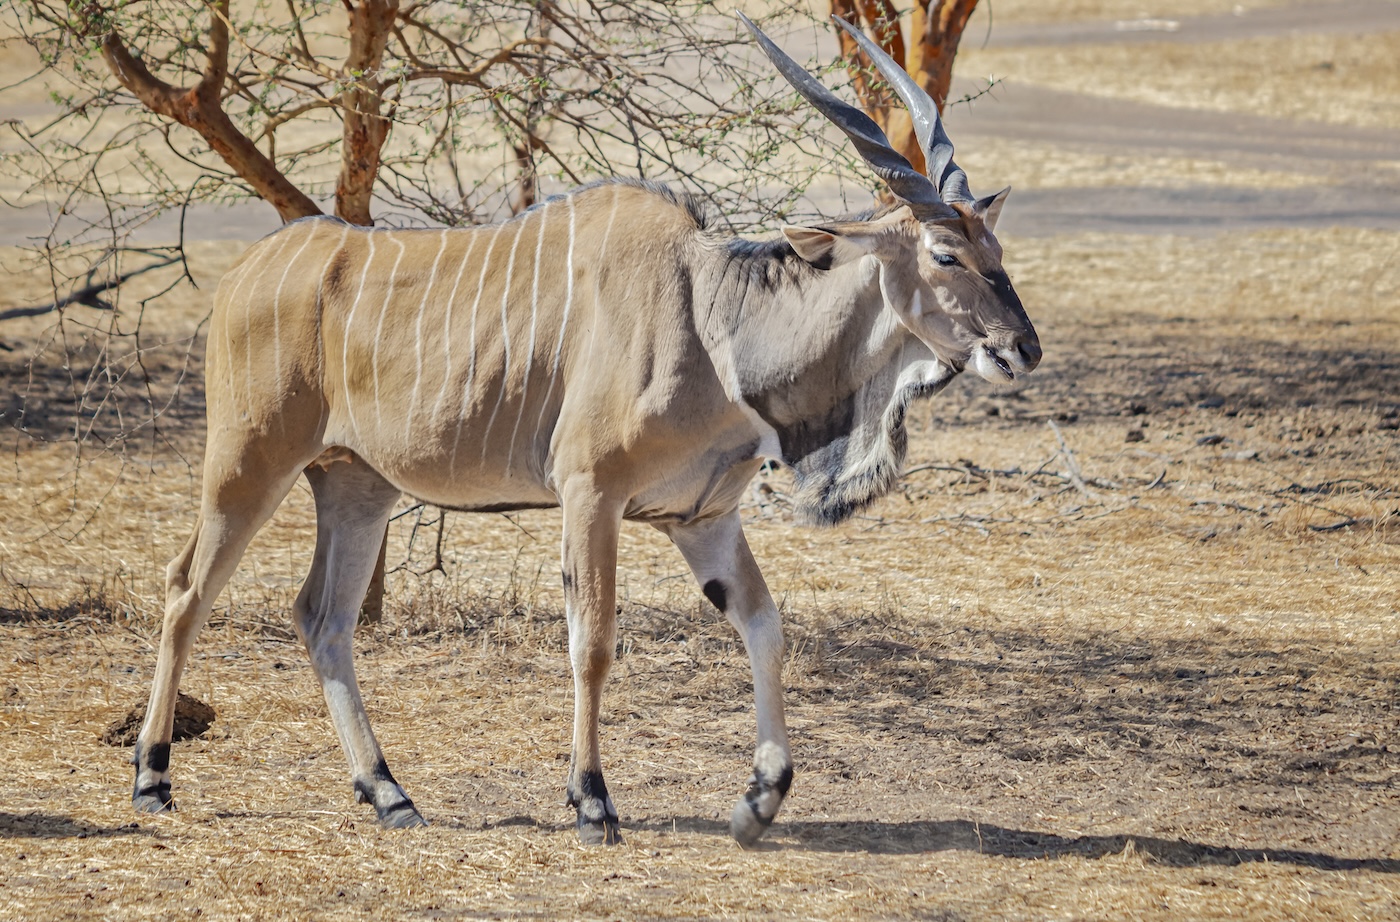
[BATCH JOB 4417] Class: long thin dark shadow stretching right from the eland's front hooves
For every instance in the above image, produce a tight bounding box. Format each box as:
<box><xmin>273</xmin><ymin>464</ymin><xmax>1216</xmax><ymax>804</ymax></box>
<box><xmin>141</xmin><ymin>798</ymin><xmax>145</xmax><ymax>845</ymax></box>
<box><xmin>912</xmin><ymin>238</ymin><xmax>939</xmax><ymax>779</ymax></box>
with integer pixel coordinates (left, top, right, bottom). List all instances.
<box><xmin>641</xmin><ymin>817</ymin><xmax>1400</xmax><ymax>874</ymax></box>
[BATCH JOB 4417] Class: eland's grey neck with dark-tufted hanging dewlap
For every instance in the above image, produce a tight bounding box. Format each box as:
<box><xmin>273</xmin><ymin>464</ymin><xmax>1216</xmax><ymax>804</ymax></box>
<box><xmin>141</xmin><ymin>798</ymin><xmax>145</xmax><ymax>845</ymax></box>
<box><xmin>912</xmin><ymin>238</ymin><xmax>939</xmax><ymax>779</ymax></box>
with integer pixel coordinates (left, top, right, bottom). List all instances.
<box><xmin>696</xmin><ymin>232</ymin><xmax>949</xmax><ymax>525</ymax></box>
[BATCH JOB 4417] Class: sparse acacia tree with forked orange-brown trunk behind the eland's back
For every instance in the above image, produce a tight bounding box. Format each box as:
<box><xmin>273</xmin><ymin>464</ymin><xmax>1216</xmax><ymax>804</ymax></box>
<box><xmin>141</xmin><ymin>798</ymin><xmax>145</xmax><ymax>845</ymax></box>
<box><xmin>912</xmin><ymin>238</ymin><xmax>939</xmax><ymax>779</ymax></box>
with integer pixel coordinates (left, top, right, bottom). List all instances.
<box><xmin>17</xmin><ymin>0</ymin><xmax>828</xmax><ymax>235</ymax></box>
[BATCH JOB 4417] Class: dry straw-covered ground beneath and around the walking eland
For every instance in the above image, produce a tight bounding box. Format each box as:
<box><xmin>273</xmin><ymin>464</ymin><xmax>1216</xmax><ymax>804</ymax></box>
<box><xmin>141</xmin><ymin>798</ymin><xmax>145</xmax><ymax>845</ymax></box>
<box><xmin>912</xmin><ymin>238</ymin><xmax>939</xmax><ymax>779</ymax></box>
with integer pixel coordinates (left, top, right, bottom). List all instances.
<box><xmin>0</xmin><ymin>0</ymin><xmax>1400</xmax><ymax>919</ymax></box>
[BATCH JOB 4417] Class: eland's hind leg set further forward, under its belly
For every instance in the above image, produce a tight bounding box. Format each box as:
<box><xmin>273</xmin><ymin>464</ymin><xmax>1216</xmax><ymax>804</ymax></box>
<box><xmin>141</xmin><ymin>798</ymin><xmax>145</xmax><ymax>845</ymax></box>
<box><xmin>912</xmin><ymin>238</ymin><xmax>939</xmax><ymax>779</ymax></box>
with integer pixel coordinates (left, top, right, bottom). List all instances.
<box><xmin>295</xmin><ymin>458</ymin><xmax>427</xmax><ymax>828</ymax></box>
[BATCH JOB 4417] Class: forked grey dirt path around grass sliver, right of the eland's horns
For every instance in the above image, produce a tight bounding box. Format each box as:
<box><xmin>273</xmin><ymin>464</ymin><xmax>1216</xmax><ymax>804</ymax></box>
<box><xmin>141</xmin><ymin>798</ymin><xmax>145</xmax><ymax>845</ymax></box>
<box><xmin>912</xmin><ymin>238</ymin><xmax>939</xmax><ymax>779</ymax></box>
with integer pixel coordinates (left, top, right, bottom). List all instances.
<box><xmin>948</xmin><ymin>84</ymin><xmax>1400</xmax><ymax>236</ymax></box>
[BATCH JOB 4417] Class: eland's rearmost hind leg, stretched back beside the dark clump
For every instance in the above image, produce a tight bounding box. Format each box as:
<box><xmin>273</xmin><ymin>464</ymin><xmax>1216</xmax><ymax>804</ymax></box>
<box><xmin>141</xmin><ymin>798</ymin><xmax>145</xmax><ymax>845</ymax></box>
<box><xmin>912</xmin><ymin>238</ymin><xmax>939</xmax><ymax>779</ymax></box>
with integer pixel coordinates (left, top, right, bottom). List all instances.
<box><xmin>132</xmin><ymin>435</ymin><xmax>305</xmax><ymax>813</ymax></box>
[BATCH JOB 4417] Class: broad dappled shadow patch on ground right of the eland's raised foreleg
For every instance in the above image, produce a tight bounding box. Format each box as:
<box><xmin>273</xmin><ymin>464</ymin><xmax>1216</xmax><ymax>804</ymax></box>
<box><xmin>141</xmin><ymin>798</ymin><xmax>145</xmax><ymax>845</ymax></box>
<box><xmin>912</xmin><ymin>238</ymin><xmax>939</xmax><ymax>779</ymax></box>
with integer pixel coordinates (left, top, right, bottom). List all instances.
<box><xmin>788</xmin><ymin>623</ymin><xmax>1400</xmax><ymax>802</ymax></box>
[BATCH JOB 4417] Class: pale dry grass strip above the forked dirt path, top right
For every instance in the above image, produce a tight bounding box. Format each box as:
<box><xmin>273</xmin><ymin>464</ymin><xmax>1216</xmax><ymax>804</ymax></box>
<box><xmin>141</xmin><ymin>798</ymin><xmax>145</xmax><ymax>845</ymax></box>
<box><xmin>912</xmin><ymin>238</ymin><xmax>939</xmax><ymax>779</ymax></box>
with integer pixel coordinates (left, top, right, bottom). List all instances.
<box><xmin>958</xmin><ymin>32</ymin><xmax>1400</xmax><ymax>129</ymax></box>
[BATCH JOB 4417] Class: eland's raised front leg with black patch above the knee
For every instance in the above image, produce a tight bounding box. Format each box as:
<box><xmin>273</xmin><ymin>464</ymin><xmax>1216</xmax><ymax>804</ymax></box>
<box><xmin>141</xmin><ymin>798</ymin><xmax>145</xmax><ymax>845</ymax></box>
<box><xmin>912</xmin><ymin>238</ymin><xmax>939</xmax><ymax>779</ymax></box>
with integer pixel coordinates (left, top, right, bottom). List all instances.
<box><xmin>662</xmin><ymin>511</ymin><xmax>792</xmax><ymax>848</ymax></box>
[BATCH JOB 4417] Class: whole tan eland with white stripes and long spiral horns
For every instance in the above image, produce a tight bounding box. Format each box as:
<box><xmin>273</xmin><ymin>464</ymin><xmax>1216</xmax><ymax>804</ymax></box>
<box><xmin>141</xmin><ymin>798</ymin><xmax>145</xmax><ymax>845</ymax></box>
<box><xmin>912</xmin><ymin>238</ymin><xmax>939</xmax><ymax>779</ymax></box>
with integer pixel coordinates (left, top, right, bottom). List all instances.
<box><xmin>133</xmin><ymin>20</ymin><xmax>1040</xmax><ymax>845</ymax></box>
